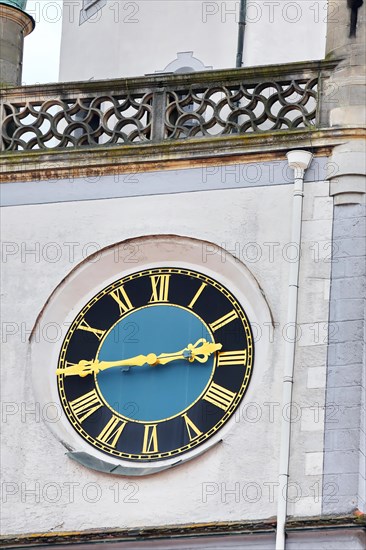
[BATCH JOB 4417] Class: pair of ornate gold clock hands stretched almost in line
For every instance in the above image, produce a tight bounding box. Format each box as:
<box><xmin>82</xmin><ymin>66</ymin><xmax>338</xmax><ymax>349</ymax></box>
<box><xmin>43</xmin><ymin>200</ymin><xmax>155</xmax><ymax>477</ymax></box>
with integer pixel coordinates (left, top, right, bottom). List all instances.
<box><xmin>56</xmin><ymin>338</ymin><xmax>222</xmax><ymax>378</ymax></box>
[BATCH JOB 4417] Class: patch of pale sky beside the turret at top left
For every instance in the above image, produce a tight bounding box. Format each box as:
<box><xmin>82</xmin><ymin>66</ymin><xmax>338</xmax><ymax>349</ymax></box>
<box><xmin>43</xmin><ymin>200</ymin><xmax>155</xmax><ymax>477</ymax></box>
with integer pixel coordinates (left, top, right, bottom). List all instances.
<box><xmin>22</xmin><ymin>0</ymin><xmax>62</xmax><ymax>85</ymax></box>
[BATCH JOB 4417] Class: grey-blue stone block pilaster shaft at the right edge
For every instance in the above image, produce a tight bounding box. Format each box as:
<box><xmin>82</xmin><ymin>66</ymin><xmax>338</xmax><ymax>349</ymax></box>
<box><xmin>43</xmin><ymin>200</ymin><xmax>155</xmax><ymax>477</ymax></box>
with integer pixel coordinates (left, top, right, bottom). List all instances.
<box><xmin>323</xmin><ymin>204</ymin><xmax>366</xmax><ymax>514</ymax></box>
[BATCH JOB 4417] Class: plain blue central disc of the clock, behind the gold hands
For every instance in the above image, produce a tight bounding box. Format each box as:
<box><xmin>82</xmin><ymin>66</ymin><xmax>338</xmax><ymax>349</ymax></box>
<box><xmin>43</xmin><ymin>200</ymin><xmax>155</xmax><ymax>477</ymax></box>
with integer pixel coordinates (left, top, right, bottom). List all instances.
<box><xmin>97</xmin><ymin>304</ymin><xmax>215</xmax><ymax>422</ymax></box>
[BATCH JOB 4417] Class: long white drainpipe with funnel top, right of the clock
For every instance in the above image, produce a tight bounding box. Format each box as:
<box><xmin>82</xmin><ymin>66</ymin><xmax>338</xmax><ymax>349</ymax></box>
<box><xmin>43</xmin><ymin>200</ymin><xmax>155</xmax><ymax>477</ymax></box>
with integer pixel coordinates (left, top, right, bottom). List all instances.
<box><xmin>276</xmin><ymin>149</ymin><xmax>313</xmax><ymax>550</ymax></box>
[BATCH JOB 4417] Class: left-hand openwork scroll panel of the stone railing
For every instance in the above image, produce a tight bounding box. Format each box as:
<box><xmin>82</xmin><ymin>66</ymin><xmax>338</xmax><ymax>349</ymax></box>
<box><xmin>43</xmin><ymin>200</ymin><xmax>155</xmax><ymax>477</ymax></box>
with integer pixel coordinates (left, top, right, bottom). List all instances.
<box><xmin>2</xmin><ymin>93</ymin><xmax>152</xmax><ymax>150</ymax></box>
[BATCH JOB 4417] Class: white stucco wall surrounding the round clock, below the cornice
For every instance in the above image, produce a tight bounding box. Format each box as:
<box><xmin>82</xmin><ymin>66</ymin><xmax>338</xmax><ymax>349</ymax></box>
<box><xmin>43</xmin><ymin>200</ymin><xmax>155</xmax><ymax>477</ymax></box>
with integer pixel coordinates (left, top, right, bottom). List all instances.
<box><xmin>1</xmin><ymin>182</ymin><xmax>332</xmax><ymax>534</ymax></box>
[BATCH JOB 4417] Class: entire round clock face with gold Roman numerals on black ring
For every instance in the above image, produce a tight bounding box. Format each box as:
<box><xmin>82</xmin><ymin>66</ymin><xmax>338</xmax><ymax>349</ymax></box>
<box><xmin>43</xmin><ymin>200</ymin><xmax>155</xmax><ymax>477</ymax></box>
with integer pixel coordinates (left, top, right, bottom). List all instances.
<box><xmin>57</xmin><ymin>267</ymin><xmax>254</xmax><ymax>462</ymax></box>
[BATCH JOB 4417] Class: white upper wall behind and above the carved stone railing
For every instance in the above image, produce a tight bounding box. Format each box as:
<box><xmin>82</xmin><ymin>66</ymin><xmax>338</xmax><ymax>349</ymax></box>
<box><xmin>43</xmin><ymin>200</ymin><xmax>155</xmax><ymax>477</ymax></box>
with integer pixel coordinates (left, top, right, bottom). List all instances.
<box><xmin>60</xmin><ymin>0</ymin><xmax>327</xmax><ymax>81</ymax></box>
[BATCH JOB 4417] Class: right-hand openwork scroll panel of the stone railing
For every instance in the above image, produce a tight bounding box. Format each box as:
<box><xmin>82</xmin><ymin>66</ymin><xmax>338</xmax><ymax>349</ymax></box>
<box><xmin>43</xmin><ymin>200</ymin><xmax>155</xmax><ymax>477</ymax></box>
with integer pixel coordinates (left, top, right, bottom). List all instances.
<box><xmin>166</xmin><ymin>78</ymin><xmax>317</xmax><ymax>139</ymax></box>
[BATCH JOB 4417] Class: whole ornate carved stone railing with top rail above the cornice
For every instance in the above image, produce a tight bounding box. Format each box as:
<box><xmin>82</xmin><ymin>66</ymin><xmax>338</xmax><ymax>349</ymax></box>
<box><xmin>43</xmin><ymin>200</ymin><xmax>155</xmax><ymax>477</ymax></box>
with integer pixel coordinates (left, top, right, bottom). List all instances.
<box><xmin>0</xmin><ymin>62</ymin><xmax>336</xmax><ymax>151</ymax></box>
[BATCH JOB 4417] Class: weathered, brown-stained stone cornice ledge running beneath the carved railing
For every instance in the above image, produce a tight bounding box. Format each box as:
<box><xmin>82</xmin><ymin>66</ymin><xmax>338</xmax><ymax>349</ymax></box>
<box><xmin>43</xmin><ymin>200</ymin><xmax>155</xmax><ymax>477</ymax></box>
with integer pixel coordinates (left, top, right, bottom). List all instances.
<box><xmin>0</xmin><ymin>128</ymin><xmax>365</xmax><ymax>183</ymax></box>
